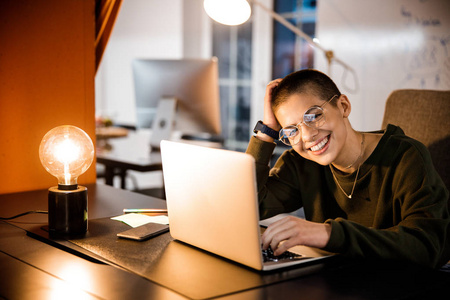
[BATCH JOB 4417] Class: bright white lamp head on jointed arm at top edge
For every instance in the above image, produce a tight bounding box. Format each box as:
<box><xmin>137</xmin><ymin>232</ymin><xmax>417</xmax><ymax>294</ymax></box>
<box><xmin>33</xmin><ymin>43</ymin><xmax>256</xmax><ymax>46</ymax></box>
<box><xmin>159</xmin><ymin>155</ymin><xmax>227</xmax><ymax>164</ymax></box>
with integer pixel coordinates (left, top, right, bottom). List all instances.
<box><xmin>203</xmin><ymin>0</ymin><xmax>252</xmax><ymax>25</ymax></box>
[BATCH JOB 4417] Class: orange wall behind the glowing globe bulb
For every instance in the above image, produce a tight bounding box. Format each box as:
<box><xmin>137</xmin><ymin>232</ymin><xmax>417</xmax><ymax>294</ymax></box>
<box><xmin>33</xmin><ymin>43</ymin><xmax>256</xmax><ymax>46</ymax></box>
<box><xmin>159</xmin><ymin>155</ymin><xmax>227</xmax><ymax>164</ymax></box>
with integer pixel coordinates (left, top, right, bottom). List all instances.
<box><xmin>0</xmin><ymin>0</ymin><xmax>95</xmax><ymax>194</ymax></box>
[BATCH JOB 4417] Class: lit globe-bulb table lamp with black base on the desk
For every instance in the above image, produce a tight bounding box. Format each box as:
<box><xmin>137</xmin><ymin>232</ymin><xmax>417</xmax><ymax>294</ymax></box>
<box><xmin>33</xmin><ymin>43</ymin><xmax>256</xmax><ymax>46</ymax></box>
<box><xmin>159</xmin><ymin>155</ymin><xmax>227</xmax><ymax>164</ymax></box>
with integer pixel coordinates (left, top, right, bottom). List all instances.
<box><xmin>39</xmin><ymin>125</ymin><xmax>94</xmax><ymax>236</ymax></box>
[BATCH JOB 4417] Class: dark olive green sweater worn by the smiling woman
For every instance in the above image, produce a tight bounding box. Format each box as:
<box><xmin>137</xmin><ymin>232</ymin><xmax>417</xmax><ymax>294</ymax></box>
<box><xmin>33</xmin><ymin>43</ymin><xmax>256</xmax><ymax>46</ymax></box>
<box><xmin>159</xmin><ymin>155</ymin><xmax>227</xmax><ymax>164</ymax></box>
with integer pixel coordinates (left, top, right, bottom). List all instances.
<box><xmin>247</xmin><ymin>125</ymin><xmax>450</xmax><ymax>267</ymax></box>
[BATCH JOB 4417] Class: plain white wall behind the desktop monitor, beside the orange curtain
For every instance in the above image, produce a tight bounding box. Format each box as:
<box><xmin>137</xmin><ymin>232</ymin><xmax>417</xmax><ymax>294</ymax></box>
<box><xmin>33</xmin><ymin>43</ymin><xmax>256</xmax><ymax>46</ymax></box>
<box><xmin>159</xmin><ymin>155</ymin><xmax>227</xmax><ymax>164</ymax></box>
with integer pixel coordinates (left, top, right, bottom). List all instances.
<box><xmin>95</xmin><ymin>0</ymin><xmax>183</xmax><ymax>125</ymax></box>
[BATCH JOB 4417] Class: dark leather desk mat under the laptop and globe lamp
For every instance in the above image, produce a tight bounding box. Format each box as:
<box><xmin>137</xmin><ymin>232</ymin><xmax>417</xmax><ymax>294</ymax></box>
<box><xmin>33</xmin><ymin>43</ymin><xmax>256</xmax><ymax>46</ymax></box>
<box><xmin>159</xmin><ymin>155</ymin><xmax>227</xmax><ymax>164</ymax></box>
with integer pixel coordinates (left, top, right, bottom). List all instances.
<box><xmin>28</xmin><ymin>218</ymin><xmax>325</xmax><ymax>299</ymax></box>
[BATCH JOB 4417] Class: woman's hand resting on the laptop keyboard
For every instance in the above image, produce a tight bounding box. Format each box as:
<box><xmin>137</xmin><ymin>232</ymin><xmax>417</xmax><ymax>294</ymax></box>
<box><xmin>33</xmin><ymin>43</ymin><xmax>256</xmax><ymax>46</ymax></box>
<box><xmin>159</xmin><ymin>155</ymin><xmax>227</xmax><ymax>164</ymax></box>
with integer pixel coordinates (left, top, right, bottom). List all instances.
<box><xmin>262</xmin><ymin>216</ymin><xmax>331</xmax><ymax>255</ymax></box>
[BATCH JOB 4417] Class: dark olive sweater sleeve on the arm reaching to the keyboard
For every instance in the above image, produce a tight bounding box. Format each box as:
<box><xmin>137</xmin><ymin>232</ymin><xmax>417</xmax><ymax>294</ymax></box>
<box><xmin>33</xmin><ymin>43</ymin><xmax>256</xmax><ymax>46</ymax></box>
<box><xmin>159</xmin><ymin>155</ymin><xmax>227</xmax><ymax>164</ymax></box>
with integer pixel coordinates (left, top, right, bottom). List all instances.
<box><xmin>325</xmin><ymin>139</ymin><xmax>450</xmax><ymax>267</ymax></box>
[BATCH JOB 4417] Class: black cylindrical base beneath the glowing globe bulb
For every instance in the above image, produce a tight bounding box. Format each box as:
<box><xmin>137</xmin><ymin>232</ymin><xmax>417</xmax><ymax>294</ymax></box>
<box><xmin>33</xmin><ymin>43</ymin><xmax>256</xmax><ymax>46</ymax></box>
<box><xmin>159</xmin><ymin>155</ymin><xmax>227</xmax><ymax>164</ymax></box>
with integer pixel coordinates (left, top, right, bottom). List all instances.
<box><xmin>48</xmin><ymin>186</ymin><xmax>88</xmax><ymax>236</ymax></box>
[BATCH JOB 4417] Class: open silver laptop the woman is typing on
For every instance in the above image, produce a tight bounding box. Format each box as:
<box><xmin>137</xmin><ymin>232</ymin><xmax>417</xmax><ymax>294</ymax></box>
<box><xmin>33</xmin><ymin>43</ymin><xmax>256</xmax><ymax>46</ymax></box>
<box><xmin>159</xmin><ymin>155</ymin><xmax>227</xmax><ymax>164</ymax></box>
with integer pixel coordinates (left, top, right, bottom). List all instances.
<box><xmin>161</xmin><ymin>140</ymin><xmax>332</xmax><ymax>271</ymax></box>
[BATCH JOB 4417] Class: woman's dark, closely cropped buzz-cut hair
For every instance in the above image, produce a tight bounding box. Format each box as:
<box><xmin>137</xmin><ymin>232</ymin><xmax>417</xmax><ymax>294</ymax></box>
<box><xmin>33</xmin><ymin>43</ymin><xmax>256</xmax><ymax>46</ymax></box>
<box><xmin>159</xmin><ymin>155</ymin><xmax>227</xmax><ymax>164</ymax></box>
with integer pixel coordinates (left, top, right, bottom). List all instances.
<box><xmin>272</xmin><ymin>69</ymin><xmax>341</xmax><ymax>111</ymax></box>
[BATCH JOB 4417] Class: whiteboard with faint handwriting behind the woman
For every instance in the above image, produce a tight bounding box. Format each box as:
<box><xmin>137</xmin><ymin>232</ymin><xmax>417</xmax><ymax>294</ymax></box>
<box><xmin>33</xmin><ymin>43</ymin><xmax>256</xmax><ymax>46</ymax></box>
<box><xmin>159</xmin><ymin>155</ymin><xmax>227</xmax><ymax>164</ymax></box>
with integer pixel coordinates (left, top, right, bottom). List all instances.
<box><xmin>315</xmin><ymin>0</ymin><xmax>450</xmax><ymax>130</ymax></box>
